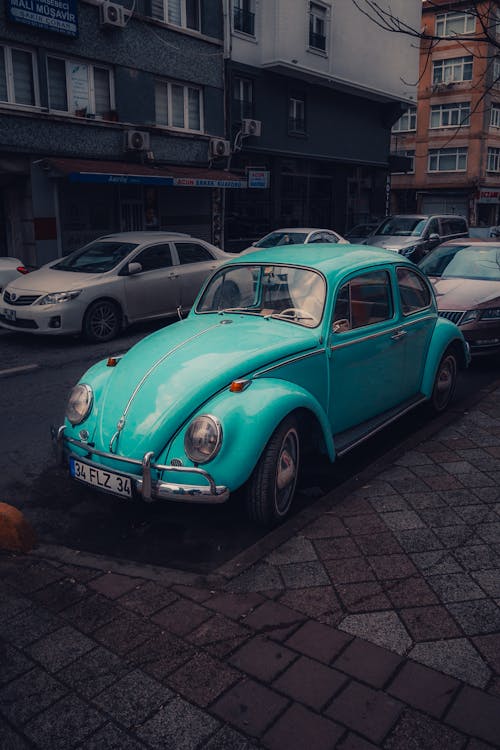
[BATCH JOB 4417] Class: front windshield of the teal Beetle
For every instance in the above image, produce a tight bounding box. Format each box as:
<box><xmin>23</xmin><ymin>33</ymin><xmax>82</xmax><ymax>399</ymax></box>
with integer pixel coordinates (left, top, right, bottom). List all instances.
<box><xmin>196</xmin><ymin>265</ymin><xmax>326</xmax><ymax>328</ymax></box>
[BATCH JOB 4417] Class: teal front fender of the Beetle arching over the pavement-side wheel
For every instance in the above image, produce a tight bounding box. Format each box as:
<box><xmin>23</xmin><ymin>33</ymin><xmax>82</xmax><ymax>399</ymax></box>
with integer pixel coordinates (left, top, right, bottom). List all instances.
<box><xmin>161</xmin><ymin>378</ymin><xmax>335</xmax><ymax>491</ymax></box>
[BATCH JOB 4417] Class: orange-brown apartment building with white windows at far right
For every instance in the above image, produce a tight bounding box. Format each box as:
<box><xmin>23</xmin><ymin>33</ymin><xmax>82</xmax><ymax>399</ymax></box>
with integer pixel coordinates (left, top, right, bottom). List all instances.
<box><xmin>392</xmin><ymin>0</ymin><xmax>500</xmax><ymax>226</ymax></box>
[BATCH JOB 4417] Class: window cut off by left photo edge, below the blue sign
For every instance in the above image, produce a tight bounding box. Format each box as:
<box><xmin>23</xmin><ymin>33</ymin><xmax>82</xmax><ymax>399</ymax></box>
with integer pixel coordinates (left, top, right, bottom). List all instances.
<box><xmin>0</xmin><ymin>46</ymin><xmax>38</xmax><ymax>107</ymax></box>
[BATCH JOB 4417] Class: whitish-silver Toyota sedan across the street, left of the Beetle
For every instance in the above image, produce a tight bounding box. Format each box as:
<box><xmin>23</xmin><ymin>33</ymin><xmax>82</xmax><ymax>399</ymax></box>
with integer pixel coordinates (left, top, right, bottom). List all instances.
<box><xmin>0</xmin><ymin>232</ymin><xmax>232</xmax><ymax>342</ymax></box>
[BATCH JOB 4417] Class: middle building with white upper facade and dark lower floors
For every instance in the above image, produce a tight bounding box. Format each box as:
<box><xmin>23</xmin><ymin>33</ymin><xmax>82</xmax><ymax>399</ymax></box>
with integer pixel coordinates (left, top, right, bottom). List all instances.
<box><xmin>225</xmin><ymin>0</ymin><xmax>421</xmax><ymax>253</ymax></box>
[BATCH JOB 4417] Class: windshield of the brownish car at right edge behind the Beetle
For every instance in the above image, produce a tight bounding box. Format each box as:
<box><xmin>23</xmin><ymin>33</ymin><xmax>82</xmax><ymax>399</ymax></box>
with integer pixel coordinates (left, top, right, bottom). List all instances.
<box><xmin>419</xmin><ymin>245</ymin><xmax>500</xmax><ymax>281</ymax></box>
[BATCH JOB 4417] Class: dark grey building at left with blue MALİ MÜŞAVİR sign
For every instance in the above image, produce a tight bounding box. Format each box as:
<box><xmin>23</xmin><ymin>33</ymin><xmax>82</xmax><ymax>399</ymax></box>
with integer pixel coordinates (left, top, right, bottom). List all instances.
<box><xmin>0</xmin><ymin>0</ymin><xmax>229</xmax><ymax>265</ymax></box>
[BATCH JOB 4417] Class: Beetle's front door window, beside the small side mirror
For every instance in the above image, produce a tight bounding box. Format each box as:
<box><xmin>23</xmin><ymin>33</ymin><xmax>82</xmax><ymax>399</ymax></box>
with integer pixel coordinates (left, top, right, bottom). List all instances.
<box><xmin>333</xmin><ymin>271</ymin><xmax>393</xmax><ymax>333</ymax></box>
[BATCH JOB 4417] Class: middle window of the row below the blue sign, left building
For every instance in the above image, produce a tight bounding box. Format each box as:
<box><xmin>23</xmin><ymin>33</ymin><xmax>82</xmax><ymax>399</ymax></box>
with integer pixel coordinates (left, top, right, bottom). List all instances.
<box><xmin>47</xmin><ymin>57</ymin><xmax>115</xmax><ymax>117</ymax></box>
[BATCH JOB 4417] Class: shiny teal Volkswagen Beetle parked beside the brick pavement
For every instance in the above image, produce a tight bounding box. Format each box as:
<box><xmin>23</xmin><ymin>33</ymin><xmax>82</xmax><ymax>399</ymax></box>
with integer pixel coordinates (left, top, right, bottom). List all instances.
<box><xmin>55</xmin><ymin>245</ymin><xmax>469</xmax><ymax>526</ymax></box>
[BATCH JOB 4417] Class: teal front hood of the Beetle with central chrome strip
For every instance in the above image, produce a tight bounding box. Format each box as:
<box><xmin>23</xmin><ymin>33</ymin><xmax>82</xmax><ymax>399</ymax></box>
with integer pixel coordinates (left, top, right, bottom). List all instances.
<box><xmin>94</xmin><ymin>315</ymin><xmax>320</xmax><ymax>458</ymax></box>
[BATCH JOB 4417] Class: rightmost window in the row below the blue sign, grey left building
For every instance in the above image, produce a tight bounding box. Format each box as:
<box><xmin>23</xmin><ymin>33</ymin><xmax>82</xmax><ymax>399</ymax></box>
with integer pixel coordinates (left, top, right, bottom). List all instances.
<box><xmin>155</xmin><ymin>81</ymin><xmax>203</xmax><ymax>133</ymax></box>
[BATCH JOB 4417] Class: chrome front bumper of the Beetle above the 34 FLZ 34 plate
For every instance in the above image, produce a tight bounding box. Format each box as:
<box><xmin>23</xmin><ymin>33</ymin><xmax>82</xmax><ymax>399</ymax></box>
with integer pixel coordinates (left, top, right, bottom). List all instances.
<box><xmin>52</xmin><ymin>425</ymin><xmax>229</xmax><ymax>504</ymax></box>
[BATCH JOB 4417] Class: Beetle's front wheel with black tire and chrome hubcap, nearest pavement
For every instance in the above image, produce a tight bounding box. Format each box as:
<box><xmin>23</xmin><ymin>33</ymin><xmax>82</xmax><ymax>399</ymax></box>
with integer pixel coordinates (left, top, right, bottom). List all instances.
<box><xmin>245</xmin><ymin>416</ymin><xmax>300</xmax><ymax>527</ymax></box>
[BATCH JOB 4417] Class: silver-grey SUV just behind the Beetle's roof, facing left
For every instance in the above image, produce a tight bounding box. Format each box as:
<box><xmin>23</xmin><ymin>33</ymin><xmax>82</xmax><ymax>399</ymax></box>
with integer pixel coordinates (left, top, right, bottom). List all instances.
<box><xmin>364</xmin><ymin>214</ymin><xmax>469</xmax><ymax>263</ymax></box>
